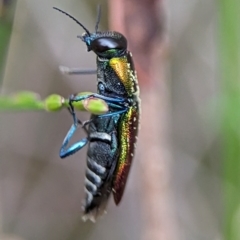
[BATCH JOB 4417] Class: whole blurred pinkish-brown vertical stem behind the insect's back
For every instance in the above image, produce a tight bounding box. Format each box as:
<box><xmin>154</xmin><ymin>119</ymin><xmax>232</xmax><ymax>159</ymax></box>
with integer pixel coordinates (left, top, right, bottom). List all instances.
<box><xmin>109</xmin><ymin>0</ymin><xmax>177</xmax><ymax>240</ymax></box>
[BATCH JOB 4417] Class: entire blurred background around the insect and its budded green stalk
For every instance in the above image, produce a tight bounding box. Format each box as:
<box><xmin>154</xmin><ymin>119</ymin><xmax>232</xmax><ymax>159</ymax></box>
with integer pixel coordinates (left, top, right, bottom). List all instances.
<box><xmin>0</xmin><ymin>0</ymin><xmax>240</xmax><ymax>240</ymax></box>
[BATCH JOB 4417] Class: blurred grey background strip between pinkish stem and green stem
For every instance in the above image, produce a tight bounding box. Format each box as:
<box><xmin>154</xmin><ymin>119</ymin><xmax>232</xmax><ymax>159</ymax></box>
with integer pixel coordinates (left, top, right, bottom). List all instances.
<box><xmin>168</xmin><ymin>0</ymin><xmax>221</xmax><ymax>240</ymax></box>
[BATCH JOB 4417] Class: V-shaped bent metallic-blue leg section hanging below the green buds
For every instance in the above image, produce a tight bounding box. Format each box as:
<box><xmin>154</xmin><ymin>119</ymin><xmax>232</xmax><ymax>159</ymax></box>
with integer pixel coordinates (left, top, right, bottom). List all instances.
<box><xmin>59</xmin><ymin>123</ymin><xmax>88</xmax><ymax>158</ymax></box>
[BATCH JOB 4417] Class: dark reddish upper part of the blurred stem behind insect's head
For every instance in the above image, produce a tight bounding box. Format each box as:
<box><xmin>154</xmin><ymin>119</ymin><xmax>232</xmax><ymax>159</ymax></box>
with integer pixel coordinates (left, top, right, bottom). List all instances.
<box><xmin>109</xmin><ymin>0</ymin><xmax>164</xmax><ymax>85</ymax></box>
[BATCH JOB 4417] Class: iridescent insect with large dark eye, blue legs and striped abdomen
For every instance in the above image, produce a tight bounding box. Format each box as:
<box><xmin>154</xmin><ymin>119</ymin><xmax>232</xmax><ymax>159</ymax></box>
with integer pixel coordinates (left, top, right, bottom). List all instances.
<box><xmin>54</xmin><ymin>8</ymin><xmax>140</xmax><ymax>221</ymax></box>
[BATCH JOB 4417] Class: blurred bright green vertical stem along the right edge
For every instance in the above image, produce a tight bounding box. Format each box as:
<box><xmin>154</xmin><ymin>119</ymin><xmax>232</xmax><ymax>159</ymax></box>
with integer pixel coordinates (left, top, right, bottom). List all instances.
<box><xmin>218</xmin><ymin>0</ymin><xmax>240</xmax><ymax>240</ymax></box>
